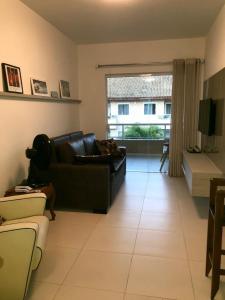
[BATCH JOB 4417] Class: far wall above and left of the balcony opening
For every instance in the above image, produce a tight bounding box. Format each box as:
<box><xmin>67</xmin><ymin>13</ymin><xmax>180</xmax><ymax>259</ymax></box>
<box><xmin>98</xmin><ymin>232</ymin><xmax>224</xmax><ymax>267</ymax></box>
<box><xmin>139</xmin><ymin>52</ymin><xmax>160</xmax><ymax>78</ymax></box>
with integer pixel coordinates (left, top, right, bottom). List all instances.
<box><xmin>78</xmin><ymin>38</ymin><xmax>205</xmax><ymax>138</ymax></box>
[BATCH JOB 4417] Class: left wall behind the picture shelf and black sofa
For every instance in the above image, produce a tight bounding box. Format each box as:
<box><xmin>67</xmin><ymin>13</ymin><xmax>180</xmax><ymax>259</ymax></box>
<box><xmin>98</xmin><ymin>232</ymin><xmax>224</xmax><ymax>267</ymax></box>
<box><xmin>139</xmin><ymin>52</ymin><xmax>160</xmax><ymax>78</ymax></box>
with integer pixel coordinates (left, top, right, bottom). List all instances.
<box><xmin>0</xmin><ymin>0</ymin><xmax>79</xmax><ymax>194</ymax></box>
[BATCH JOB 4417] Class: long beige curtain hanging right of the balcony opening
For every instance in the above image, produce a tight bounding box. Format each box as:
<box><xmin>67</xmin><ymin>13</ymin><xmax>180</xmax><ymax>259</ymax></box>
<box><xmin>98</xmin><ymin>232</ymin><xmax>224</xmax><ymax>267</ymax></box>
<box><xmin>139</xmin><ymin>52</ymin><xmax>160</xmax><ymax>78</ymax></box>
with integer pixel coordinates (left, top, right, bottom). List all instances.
<box><xmin>169</xmin><ymin>59</ymin><xmax>201</xmax><ymax>176</ymax></box>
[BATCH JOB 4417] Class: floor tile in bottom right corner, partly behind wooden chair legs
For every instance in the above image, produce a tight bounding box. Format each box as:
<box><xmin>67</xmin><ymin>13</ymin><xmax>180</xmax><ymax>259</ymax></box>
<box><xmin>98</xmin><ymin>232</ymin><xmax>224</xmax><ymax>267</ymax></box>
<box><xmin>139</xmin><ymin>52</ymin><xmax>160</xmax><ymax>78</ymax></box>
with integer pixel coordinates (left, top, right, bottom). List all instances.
<box><xmin>190</xmin><ymin>261</ymin><xmax>225</xmax><ymax>300</ymax></box>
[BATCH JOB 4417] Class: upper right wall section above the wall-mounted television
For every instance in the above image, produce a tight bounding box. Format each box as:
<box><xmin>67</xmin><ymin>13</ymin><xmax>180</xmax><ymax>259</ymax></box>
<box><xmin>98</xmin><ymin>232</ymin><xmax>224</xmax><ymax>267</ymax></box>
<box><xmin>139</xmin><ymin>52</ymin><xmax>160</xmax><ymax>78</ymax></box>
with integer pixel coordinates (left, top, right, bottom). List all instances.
<box><xmin>205</xmin><ymin>5</ymin><xmax>225</xmax><ymax>79</ymax></box>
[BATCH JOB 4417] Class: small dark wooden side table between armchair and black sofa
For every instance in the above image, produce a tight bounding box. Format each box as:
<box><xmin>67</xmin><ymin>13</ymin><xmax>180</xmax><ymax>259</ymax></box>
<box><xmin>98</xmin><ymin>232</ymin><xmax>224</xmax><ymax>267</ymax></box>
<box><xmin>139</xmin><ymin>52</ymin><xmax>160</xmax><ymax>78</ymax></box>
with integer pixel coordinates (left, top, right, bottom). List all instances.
<box><xmin>4</xmin><ymin>183</ymin><xmax>56</xmax><ymax>220</ymax></box>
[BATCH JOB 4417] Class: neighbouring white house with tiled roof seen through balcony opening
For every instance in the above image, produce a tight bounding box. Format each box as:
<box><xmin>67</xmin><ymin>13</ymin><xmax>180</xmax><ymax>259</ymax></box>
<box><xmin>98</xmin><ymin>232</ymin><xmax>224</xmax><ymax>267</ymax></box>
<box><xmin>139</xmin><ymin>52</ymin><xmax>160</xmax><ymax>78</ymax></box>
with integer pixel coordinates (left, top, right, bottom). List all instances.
<box><xmin>106</xmin><ymin>74</ymin><xmax>172</xmax><ymax>139</ymax></box>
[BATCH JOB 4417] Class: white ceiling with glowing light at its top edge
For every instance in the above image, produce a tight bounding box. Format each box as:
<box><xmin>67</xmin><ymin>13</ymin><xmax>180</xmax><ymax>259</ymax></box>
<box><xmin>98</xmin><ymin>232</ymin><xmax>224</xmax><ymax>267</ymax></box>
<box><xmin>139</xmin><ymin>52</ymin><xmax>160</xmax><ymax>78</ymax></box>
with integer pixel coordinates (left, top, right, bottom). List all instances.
<box><xmin>21</xmin><ymin>0</ymin><xmax>225</xmax><ymax>44</ymax></box>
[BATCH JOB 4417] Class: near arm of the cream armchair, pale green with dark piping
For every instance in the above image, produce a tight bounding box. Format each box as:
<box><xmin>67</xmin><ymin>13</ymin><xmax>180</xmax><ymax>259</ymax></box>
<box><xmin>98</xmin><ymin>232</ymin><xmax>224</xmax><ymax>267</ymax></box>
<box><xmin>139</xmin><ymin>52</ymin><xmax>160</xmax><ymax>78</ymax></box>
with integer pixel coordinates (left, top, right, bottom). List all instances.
<box><xmin>0</xmin><ymin>223</ymin><xmax>38</xmax><ymax>300</ymax></box>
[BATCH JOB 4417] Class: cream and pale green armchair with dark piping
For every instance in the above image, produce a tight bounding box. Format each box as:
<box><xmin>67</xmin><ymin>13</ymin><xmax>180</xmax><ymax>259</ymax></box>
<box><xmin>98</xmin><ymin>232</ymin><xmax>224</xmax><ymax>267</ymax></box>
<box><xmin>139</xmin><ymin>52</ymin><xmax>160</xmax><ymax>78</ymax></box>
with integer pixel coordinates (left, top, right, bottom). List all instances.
<box><xmin>0</xmin><ymin>193</ymin><xmax>49</xmax><ymax>300</ymax></box>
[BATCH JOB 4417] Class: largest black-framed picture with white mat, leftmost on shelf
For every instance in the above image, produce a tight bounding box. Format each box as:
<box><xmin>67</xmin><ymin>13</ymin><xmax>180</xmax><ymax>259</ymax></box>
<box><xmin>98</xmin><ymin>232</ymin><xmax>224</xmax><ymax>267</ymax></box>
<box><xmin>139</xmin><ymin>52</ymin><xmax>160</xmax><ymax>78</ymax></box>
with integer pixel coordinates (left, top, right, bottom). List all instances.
<box><xmin>2</xmin><ymin>63</ymin><xmax>23</xmax><ymax>94</ymax></box>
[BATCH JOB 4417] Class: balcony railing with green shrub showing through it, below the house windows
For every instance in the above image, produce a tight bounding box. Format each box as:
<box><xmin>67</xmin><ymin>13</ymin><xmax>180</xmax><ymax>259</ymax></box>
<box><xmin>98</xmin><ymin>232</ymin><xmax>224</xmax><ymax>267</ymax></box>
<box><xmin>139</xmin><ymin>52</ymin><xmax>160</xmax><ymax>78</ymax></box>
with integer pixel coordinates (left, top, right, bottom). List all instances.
<box><xmin>108</xmin><ymin>123</ymin><xmax>171</xmax><ymax>140</ymax></box>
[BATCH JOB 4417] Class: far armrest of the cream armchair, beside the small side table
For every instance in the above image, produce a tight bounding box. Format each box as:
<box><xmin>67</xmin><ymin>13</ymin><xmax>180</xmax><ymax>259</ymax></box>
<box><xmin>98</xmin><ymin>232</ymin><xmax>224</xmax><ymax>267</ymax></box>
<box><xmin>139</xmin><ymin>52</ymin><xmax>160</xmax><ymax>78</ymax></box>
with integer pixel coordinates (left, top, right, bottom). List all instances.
<box><xmin>0</xmin><ymin>193</ymin><xmax>46</xmax><ymax>220</ymax></box>
